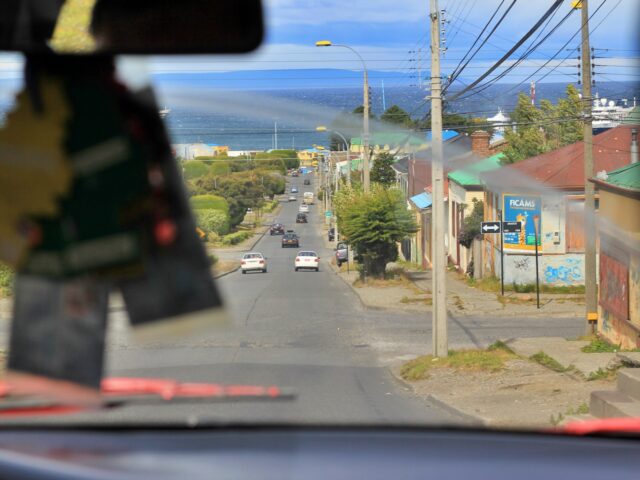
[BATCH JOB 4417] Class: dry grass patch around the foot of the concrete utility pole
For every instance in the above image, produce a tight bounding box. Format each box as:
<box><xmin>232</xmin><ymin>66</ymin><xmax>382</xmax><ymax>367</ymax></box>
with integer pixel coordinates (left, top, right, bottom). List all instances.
<box><xmin>400</xmin><ymin>342</ymin><xmax>516</xmax><ymax>381</ymax></box>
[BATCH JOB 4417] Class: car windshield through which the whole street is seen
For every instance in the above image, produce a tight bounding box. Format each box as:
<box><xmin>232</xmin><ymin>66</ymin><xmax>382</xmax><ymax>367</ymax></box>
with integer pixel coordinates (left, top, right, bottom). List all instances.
<box><xmin>0</xmin><ymin>0</ymin><xmax>640</xmax><ymax>436</ymax></box>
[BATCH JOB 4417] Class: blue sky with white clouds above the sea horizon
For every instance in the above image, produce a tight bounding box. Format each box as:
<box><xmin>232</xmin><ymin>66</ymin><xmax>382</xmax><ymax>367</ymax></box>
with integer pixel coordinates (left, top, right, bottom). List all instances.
<box><xmin>0</xmin><ymin>0</ymin><xmax>640</xmax><ymax>87</ymax></box>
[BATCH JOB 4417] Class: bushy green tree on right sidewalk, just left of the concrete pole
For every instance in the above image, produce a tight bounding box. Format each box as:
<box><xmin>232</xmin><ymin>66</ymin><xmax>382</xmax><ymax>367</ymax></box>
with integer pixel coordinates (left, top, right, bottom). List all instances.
<box><xmin>334</xmin><ymin>185</ymin><xmax>418</xmax><ymax>278</ymax></box>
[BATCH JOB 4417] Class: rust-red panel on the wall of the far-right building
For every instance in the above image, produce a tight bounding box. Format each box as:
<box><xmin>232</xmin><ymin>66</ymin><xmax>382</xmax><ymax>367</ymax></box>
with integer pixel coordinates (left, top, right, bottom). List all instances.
<box><xmin>600</xmin><ymin>252</ymin><xmax>629</xmax><ymax>320</ymax></box>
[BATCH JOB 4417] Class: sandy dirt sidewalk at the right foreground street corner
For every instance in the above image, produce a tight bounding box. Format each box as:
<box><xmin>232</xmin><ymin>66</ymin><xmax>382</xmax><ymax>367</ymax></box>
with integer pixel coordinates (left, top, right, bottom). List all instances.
<box><xmin>391</xmin><ymin>337</ymin><xmax>640</xmax><ymax>428</ymax></box>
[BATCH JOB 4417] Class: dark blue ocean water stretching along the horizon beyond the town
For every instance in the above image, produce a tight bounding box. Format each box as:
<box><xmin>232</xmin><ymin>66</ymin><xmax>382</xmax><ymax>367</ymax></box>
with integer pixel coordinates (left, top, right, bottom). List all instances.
<box><xmin>0</xmin><ymin>74</ymin><xmax>640</xmax><ymax>150</ymax></box>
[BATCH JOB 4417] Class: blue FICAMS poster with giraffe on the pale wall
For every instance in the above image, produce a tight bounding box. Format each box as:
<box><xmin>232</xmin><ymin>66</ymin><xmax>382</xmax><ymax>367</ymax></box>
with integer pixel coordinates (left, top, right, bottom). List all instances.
<box><xmin>502</xmin><ymin>193</ymin><xmax>542</xmax><ymax>252</ymax></box>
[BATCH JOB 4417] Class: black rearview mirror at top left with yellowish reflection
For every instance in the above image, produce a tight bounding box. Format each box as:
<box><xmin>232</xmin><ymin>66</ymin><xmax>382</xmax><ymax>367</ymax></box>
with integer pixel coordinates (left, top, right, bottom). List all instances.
<box><xmin>0</xmin><ymin>0</ymin><xmax>264</xmax><ymax>54</ymax></box>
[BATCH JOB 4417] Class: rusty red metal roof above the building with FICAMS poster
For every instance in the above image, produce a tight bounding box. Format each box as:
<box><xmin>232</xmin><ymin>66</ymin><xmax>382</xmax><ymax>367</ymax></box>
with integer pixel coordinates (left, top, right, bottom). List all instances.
<box><xmin>480</xmin><ymin>125</ymin><xmax>632</xmax><ymax>190</ymax></box>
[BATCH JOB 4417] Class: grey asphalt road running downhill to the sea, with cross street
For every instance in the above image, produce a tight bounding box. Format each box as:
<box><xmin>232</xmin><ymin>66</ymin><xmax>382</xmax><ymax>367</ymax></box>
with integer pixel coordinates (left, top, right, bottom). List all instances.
<box><xmin>0</xmin><ymin>173</ymin><xmax>581</xmax><ymax>424</ymax></box>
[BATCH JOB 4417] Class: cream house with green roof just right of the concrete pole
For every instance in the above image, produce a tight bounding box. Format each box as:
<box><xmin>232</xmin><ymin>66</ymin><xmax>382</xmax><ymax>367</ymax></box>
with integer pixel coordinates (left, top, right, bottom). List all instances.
<box><xmin>447</xmin><ymin>153</ymin><xmax>503</xmax><ymax>272</ymax></box>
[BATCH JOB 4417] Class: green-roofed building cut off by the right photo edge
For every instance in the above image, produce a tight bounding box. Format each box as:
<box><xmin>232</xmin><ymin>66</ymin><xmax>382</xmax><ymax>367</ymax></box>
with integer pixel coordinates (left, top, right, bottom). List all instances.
<box><xmin>590</xmin><ymin>159</ymin><xmax>640</xmax><ymax>349</ymax></box>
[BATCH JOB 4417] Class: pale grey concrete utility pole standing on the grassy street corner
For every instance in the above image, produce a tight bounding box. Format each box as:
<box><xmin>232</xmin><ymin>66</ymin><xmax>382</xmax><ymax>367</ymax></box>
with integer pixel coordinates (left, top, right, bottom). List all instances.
<box><xmin>430</xmin><ymin>0</ymin><xmax>449</xmax><ymax>357</ymax></box>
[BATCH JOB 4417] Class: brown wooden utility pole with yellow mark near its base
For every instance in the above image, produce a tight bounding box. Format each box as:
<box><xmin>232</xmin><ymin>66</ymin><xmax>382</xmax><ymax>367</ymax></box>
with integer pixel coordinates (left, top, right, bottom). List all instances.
<box><xmin>580</xmin><ymin>0</ymin><xmax>598</xmax><ymax>334</ymax></box>
